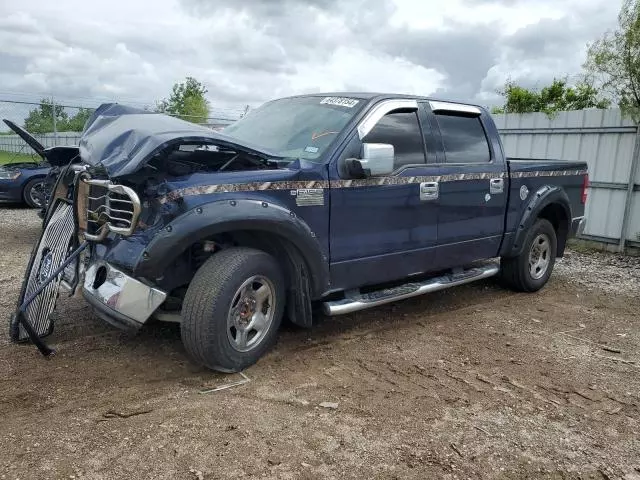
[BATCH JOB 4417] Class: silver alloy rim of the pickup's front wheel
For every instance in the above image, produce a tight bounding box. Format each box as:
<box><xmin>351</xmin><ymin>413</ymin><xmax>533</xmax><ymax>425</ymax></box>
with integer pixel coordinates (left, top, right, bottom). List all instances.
<box><xmin>227</xmin><ymin>275</ymin><xmax>276</xmax><ymax>352</ymax></box>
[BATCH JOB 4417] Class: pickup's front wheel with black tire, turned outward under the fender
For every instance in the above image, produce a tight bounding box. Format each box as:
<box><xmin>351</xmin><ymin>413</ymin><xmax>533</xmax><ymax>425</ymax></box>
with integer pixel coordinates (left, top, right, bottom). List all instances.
<box><xmin>180</xmin><ymin>247</ymin><xmax>286</xmax><ymax>372</ymax></box>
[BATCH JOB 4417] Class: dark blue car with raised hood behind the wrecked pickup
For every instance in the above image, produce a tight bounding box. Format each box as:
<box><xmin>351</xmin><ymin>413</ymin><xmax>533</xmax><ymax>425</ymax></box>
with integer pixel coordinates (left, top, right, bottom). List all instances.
<box><xmin>0</xmin><ymin>120</ymin><xmax>77</xmax><ymax>213</ymax></box>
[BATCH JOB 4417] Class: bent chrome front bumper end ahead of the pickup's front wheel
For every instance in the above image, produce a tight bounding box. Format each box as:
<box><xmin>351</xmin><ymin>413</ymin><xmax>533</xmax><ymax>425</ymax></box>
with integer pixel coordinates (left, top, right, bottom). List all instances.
<box><xmin>82</xmin><ymin>262</ymin><xmax>167</xmax><ymax>330</ymax></box>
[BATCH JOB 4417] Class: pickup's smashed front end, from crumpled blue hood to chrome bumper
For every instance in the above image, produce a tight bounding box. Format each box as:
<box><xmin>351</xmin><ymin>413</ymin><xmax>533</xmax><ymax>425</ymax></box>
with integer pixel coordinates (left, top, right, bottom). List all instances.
<box><xmin>10</xmin><ymin>105</ymin><xmax>288</xmax><ymax>355</ymax></box>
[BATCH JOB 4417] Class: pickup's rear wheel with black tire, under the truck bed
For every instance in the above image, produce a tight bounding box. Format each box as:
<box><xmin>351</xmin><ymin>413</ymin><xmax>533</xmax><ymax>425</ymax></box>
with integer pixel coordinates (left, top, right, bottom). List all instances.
<box><xmin>501</xmin><ymin>218</ymin><xmax>558</xmax><ymax>292</ymax></box>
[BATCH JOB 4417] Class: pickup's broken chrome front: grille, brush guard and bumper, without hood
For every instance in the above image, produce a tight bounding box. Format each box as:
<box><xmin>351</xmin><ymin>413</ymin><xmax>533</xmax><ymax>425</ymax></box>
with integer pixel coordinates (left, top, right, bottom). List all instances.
<box><xmin>10</xmin><ymin>165</ymin><xmax>166</xmax><ymax>354</ymax></box>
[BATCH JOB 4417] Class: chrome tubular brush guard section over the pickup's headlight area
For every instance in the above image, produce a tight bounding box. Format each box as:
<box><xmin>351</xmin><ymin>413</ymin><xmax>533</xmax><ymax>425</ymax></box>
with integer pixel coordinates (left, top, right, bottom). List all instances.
<box><xmin>79</xmin><ymin>179</ymin><xmax>140</xmax><ymax>241</ymax></box>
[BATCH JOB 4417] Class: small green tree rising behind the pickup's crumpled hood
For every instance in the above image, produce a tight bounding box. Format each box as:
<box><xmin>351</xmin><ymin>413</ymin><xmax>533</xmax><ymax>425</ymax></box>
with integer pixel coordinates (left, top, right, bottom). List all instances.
<box><xmin>156</xmin><ymin>77</ymin><xmax>209</xmax><ymax>123</ymax></box>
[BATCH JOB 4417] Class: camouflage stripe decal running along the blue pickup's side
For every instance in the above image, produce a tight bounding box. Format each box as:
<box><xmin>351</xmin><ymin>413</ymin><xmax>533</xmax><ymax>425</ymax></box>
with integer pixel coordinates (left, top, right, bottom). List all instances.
<box><xmin>159</xmin><ymin>170</ymin><xmax>587</xmax><ymax>203</ymax></box>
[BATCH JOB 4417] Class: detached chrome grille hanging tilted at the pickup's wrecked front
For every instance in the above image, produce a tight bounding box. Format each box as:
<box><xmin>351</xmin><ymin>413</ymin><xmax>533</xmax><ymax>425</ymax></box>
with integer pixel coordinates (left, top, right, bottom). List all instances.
<box><xmin>16</xmin><ymin>202</ymin><xmax>75</xmax><ymax>341</ymax></box>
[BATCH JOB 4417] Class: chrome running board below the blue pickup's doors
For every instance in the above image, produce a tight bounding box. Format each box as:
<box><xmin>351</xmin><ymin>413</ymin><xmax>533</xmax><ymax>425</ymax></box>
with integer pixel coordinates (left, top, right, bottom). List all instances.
<box><xmin>322</xmin><ymin>264</ymin><xmax>500</xmax><ymax>316</ymax></box>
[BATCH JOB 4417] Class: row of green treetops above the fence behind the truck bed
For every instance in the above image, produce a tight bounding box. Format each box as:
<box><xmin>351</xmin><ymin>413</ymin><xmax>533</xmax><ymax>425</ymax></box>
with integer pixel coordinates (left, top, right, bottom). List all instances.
<box><xmin>491</xmin><ymin>78</ymin><xmax>611</xmax><ymax>116</ymax></box>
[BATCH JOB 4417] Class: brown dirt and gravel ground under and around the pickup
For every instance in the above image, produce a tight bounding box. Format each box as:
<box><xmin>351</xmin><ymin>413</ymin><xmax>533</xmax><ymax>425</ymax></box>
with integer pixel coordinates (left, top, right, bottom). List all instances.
<box><xmin>0</xmin><ymin>209</ymin><xmax>640</xmax><ymax>479</ymax></box>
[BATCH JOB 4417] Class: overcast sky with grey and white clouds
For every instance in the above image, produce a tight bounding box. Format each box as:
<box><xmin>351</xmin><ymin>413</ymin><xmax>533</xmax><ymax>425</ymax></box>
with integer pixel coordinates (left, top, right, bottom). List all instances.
<box><xmin>0</xmin><ymin>0</ymin><xmax>621</xmax><ymax>116</ymax></box>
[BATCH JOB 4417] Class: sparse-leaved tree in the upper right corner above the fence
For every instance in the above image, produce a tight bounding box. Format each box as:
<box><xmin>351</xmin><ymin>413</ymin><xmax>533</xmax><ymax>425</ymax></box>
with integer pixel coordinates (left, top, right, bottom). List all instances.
<box><xmin>584</xmin><ymin>0</ymin><xmax>640</xmax><ymax>123</ymax></box>
